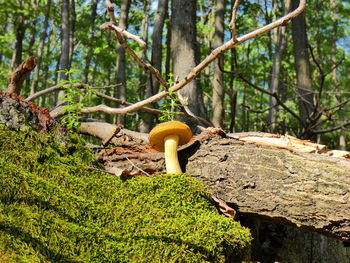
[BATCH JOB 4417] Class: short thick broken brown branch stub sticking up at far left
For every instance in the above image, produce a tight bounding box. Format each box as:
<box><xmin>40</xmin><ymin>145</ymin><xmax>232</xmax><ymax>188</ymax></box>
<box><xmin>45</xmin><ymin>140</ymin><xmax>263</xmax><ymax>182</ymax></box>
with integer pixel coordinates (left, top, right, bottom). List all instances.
<box><xmin>7</xmin><ymin>56</ymin><xmax>38</xmax><ymax>95</ymax></box>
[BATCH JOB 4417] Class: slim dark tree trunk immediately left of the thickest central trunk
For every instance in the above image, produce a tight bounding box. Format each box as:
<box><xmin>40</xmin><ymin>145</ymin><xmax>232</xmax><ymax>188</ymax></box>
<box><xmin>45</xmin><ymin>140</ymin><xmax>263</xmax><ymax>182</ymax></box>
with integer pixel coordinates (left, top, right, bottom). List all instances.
<box><xmin>139</xmin><ymin>0</ymin><xmax>168</xmax><ymax>132</ymax></box>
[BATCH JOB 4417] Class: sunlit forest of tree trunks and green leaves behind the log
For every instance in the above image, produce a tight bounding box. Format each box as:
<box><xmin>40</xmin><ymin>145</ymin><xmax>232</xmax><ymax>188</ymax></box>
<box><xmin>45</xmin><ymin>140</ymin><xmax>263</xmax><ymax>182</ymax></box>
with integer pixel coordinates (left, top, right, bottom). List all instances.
<box><xmin>0</xmin><ymin>0</ymin><xmax>350</xmax><ymax>150</ymax></box>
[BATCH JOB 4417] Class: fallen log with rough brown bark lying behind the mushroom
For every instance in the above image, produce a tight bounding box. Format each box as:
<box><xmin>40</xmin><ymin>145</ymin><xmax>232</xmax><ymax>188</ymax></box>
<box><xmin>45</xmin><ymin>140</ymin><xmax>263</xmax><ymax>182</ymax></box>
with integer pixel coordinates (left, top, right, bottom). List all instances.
<box><xmin>99</xmin><ymin>129</ymin><xmax>350</xmax><ymax>242</ymax></box>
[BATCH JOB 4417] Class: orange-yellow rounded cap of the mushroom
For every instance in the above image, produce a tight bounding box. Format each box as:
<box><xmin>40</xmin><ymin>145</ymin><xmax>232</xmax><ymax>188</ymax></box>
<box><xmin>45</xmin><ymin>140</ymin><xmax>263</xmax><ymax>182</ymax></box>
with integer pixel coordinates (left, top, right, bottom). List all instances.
<box><xmin>149</xmin><ymin>121</ymin><xmax>192</xmax><ymax>152</ymax></box>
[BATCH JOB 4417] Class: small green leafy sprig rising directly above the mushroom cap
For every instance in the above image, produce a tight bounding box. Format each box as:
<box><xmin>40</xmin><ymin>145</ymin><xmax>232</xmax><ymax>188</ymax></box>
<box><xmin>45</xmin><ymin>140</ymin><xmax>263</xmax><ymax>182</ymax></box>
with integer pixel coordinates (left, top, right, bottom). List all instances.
<box><xmin>159</xmin><ymin>73</ymin><xmax>181</xmax><ymax>122</ymax></box>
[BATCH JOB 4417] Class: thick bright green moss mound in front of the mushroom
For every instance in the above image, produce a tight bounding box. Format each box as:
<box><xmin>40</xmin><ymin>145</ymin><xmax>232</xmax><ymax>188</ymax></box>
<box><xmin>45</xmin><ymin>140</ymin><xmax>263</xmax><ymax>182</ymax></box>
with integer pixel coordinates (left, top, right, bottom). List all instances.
<box><xmin>0</xmin><ymin>126</ymin><xmax>251</xmax><ymax>263</ymax></box>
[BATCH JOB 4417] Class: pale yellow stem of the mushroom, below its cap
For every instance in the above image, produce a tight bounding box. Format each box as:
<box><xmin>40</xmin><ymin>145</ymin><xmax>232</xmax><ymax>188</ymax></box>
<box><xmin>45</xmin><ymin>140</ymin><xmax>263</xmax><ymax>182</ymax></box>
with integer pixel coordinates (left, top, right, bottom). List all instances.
<box><xmin>164</xmin><ymin>135</ymin><xmax>182</xmax><ymax>174</ymax></box>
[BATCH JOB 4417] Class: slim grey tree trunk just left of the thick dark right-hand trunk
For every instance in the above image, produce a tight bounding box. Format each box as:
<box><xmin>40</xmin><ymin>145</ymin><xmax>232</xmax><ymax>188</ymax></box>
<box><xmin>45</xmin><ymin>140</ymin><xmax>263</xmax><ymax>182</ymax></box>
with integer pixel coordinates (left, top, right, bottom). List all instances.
<box><xmin>269</xmin><ymin>0</ymin><xmax>291</xmax><ymax>133</ymax></box>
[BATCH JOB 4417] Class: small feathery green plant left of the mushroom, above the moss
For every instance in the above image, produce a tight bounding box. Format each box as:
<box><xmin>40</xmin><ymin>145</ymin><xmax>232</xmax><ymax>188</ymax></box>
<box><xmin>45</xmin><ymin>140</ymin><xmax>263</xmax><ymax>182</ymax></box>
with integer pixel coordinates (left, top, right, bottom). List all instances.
<box><xmin>58</xmin><ymin>69</ymin><xmax>95</xmax><ymax>130</ymax></box>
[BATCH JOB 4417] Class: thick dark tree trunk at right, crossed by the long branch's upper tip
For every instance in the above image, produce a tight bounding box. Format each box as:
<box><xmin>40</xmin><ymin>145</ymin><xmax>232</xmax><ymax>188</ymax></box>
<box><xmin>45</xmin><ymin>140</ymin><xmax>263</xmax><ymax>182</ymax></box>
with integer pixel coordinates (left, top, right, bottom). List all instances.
<box><xmin>292</xmin><ymin>0</ymin><xmax>315</xmax><ymax>138</ymax></box>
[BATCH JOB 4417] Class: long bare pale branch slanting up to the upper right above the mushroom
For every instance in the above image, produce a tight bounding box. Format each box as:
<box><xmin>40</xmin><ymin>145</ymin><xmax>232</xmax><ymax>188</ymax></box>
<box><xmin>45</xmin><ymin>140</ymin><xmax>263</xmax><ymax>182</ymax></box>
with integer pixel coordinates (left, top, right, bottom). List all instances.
<box><xmin>85</xmin><ymin>0</ymin><xmax>306</xmax><ymax>114</ymax></box>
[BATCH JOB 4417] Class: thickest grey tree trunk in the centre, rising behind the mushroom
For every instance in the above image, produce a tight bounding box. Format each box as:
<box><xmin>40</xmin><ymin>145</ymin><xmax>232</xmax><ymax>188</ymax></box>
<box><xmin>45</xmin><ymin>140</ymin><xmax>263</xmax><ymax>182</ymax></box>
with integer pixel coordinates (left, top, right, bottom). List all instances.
<box><xmin>171</xmin><ymin>0</ymin><xmax>206</xmax><ymax>118</ymax></box>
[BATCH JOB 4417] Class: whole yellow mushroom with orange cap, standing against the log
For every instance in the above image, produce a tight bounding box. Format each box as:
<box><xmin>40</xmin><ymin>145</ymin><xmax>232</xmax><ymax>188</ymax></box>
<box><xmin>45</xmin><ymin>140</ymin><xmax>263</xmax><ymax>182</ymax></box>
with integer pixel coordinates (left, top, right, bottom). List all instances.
<box><xmin>149</xmin><ymin>121</ymin><xmax>192</xmax><ymax>174</ymax></box>
